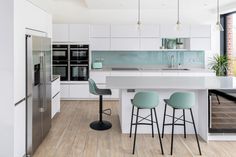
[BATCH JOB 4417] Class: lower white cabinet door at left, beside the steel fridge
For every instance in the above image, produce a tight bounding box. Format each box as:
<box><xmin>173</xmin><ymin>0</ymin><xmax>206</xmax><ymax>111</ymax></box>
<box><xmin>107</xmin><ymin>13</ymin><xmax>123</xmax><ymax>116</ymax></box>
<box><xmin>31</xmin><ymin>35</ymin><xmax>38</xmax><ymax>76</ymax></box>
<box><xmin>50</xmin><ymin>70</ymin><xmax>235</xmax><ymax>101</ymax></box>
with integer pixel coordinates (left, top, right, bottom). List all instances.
<box><xmin>14</xmin><ymin>101</ymin><xmax>26</xmax><ymax>157</ymax></box>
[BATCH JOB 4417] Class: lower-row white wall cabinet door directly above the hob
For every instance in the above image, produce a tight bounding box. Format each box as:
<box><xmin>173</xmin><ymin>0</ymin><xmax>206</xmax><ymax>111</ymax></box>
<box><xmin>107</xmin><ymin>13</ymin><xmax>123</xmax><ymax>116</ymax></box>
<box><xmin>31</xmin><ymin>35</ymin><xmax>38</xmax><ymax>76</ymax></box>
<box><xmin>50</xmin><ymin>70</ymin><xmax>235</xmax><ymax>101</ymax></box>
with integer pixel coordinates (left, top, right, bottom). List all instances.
<box><xmin>111</xmin><ymin>38</ymin><xmax>139</xmax><ymax>50</ymax></box>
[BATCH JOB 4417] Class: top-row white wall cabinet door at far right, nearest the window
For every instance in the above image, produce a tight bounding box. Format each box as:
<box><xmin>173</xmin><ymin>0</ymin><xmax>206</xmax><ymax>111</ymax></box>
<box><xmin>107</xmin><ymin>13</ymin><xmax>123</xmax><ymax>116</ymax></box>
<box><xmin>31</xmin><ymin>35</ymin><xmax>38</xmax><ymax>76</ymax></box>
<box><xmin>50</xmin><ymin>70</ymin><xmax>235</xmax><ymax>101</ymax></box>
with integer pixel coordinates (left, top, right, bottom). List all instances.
<box><xmin>190</xmin><ymin>25</ymin><xmax>211</xmax><ymax>38</ymax></box>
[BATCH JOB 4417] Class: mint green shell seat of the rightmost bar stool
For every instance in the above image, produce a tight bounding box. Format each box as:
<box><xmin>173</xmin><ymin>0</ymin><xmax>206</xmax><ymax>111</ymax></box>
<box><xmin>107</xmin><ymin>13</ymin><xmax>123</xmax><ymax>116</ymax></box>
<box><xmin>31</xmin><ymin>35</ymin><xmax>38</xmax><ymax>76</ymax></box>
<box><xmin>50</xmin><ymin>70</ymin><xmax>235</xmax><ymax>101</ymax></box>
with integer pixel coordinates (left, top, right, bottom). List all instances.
<box><xmin>169</xmin><ymin>92</ymin><xmax>195</xmax><ymax>109</ymax></box>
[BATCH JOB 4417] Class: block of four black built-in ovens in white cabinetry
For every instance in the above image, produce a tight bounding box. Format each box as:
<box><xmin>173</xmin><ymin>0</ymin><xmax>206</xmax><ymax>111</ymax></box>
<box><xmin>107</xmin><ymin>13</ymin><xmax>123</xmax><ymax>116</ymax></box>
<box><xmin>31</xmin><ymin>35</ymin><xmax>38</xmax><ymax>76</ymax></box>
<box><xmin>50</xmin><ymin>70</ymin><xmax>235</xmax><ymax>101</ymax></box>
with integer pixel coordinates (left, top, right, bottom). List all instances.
<box><xmin>53</xmin><ymin>44</ymin><xmax>89</xmax><ymax>81</ymax></box>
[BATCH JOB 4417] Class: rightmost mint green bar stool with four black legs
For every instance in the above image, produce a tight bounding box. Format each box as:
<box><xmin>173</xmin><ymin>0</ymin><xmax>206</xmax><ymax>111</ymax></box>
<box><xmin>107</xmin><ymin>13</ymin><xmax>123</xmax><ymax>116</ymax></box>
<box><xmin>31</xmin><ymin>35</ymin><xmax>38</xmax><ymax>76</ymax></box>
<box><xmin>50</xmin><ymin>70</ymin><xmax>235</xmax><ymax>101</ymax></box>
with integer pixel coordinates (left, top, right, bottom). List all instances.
<box><xmin>162</xmin><ymin>92</ymin><xmax>202</xmax><ymax>155</ymax></box>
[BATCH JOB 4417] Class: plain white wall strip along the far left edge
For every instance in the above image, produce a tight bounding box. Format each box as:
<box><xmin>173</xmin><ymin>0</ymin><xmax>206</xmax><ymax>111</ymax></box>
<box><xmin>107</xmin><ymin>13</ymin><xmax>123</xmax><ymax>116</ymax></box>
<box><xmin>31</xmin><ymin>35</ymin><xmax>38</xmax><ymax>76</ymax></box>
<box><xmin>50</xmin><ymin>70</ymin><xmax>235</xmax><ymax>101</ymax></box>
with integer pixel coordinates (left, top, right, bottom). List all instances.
<box><xmin>0</xmin><ymin>0</ymin><xmax>14</xmax><ymax>157</ymax></box>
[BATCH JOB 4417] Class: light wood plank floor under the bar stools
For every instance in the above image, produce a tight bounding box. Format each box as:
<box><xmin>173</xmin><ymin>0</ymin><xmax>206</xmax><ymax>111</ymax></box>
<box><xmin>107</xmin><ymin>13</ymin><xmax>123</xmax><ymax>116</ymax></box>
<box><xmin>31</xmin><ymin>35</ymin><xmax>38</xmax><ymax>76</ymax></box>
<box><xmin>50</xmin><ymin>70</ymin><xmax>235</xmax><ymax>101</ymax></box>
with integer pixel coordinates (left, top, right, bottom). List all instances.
<box><xmin>34</xmin><ymin>101</ymin><xmax>236</xmax><ymax>157</ymax></box>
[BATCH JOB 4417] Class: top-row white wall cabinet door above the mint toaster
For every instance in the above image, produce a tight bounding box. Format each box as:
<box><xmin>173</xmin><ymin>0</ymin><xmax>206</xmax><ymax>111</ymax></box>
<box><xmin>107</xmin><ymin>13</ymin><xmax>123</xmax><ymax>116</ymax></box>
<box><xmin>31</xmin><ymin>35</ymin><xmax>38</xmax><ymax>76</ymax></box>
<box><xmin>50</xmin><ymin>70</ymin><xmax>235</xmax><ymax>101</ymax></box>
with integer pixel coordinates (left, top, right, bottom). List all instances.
<box><xmin>90</xmin><ymin>25</ymin><xmax>111</xmax><ymax>38</ymax></box>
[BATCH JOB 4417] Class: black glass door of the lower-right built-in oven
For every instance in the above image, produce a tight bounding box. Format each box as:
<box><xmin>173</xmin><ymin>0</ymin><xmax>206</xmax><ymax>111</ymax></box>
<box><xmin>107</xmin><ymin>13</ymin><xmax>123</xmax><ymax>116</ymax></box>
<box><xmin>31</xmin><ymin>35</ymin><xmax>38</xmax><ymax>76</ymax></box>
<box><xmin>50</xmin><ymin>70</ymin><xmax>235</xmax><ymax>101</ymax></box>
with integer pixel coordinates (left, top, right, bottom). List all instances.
<box><xmin>70</xmin><ymin>65</ymin><xmax>89</xmax><ymax>81</ymax></box>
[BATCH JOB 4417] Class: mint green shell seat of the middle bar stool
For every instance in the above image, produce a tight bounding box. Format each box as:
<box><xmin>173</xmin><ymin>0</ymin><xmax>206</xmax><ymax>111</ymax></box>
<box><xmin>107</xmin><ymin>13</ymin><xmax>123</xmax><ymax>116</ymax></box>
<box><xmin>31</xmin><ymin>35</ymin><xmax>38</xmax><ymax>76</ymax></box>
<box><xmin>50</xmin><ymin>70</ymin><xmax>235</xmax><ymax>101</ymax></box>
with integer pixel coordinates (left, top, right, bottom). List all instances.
<box><xmin>132</xmin><ymin>92</ymin><xmax>159</xmax><ymax>109</ymax></box>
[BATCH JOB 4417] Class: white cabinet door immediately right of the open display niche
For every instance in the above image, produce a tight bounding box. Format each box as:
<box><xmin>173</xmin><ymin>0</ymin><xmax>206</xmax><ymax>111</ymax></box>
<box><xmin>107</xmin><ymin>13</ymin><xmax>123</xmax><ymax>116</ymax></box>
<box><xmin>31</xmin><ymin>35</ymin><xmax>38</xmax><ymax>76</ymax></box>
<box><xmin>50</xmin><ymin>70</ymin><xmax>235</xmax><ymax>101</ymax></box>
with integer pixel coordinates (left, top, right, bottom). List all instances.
<box><xmin>190</xmin><ymin>38</ymin><xmax>211</xmax><ymax>50</ymax></box>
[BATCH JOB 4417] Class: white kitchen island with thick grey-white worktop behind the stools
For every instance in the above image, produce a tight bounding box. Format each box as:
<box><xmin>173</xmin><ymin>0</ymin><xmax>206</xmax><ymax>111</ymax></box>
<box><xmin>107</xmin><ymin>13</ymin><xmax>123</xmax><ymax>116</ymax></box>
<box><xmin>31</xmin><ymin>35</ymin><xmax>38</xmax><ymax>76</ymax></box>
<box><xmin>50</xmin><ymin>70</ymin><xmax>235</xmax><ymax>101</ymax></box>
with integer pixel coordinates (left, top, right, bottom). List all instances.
<box><xmin>106</xmin><ymin>76</ymin><xmax>236</xmax><ymax>141</ymax></box>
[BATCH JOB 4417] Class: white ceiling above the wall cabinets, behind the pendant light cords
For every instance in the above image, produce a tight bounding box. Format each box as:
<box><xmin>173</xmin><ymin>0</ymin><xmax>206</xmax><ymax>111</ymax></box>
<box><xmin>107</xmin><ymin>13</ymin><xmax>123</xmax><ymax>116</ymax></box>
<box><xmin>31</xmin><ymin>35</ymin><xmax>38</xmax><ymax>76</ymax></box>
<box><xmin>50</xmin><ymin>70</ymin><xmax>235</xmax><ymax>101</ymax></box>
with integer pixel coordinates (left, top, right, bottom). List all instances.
<box><xmin>29</xmin><ymin>0</ymin><xmax>236</xmax><ymax>23</ymax></box>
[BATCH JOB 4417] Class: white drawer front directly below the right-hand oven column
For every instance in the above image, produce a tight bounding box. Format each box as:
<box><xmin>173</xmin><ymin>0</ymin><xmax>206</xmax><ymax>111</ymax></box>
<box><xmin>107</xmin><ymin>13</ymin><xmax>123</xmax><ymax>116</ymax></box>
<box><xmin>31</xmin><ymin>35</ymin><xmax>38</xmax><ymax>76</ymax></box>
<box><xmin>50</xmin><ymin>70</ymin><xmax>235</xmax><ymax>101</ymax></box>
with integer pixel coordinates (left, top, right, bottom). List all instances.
<box><xmin>70</xmin><ymin>84</ymin><xmax>89</xmax><ymax>99</ymax></box>
